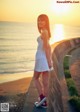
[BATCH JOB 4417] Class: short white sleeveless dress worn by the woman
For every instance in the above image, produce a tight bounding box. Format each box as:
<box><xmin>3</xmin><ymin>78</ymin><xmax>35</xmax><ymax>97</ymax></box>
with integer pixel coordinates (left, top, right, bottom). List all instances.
<box><xmin>34</xmin><ymin>36</ymin><xmax>49</xmax><ymax>72</ymax></box>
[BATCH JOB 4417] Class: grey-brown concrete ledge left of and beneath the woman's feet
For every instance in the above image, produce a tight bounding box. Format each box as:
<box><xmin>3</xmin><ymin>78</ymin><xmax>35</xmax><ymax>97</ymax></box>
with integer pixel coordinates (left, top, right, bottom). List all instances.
<box><xmin>23</xmin><ymin>79</ymin><xmax>47</xmax><ymax>112</ymax></box>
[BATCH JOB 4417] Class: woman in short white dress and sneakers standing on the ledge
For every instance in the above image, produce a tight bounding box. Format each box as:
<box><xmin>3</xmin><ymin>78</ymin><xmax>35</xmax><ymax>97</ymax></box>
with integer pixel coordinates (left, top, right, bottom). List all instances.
<box><xmin>34</xmin><ymin>14</ymin><xmax>52</xmax><ymax>107</ymax></box>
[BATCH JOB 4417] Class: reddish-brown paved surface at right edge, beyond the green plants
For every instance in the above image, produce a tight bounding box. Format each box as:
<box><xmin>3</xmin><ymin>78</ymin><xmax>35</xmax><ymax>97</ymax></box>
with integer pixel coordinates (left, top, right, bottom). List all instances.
<box><xmin>69</xmin><ymin>47</ymin><xmax>80</xmax><ymax>96</ymax></box>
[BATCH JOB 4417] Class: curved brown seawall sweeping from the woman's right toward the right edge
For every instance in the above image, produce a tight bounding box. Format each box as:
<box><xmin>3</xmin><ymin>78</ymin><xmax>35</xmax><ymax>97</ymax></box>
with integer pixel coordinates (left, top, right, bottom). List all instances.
<box><xmin>48</xmin><ymin>38</ymin><xmax>80</xmax><ymax>112</ymax></box>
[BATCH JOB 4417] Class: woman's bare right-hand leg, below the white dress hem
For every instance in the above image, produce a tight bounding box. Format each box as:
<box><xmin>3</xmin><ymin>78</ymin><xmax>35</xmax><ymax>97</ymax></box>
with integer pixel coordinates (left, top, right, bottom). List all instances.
<box><xmin>42</xmin><ymin>71</ymin><xmax>49</xmax><ymax>97</ymax></box>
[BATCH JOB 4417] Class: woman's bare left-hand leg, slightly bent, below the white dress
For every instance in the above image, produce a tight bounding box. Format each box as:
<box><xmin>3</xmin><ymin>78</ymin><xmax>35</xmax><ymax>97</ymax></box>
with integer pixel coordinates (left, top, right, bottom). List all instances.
<box><xmin>34</xmin><ymin>71</ymin><xmax>43</xmax><ymax>95</ymax></box>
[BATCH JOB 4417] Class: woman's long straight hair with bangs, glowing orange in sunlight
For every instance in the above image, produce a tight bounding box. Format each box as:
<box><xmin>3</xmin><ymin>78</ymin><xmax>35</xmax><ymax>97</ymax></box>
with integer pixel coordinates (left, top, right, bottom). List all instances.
<box><xmin>37</xmin><ymin>14</ymin><xmax>51</xmax><ymax>38</ymax></box>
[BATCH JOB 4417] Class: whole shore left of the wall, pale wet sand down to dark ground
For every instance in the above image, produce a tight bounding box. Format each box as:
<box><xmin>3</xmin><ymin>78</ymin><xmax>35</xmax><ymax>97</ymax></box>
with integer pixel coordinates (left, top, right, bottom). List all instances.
<box><xmin>0</xmin><ymin>72</ymin><xmax>33</xmax><ymax>112</ymax></box>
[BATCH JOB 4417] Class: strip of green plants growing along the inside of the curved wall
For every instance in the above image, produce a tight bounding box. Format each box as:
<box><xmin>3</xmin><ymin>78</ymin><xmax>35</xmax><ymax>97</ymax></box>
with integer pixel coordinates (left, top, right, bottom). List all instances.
<box><xmin>63</xmin><ymin>56</ymin><xmax>80</xmax><ymax>112</ymax></box>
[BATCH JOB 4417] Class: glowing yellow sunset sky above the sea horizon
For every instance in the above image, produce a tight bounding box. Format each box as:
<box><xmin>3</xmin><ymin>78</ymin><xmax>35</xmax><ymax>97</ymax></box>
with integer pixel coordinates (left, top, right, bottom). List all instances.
<box><xmin>0</xmin><ymin>0</ymin><xmax>80</xmax><ymax>26</ymax></box>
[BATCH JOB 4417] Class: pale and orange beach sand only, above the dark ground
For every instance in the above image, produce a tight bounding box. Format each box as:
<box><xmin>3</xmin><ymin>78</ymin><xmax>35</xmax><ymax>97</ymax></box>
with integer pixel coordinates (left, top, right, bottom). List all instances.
<box><xmin>0</xmin><ymin>72</ymin><xmax>33</xmax><ymax>95</ymax></box>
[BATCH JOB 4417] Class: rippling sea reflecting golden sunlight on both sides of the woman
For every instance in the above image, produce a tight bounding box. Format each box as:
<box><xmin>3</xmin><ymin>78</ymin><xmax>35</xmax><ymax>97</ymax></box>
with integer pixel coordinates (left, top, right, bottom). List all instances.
<box><xmin>0</xmin><ymin>22</ymin><xmax>80</xmax><ymax>74</ymax></box>
